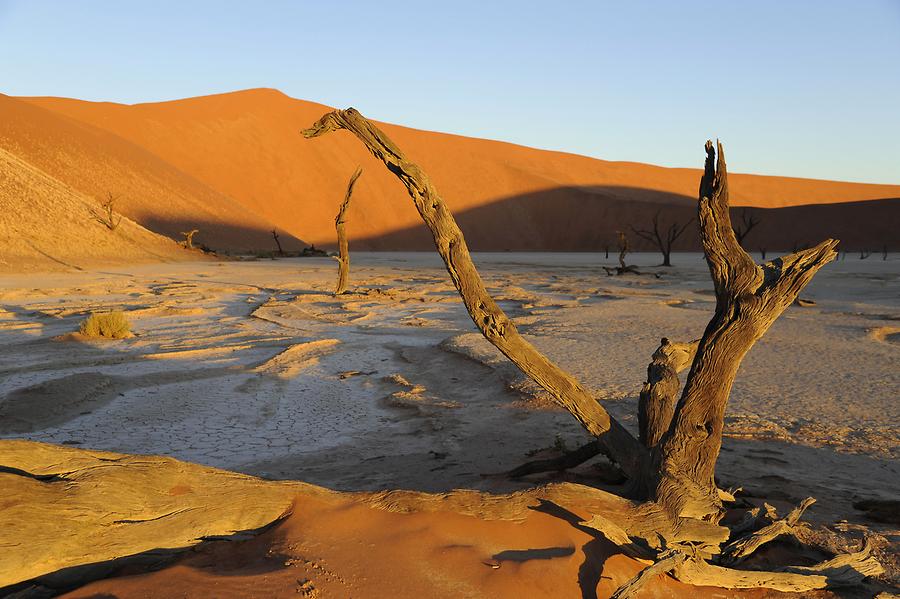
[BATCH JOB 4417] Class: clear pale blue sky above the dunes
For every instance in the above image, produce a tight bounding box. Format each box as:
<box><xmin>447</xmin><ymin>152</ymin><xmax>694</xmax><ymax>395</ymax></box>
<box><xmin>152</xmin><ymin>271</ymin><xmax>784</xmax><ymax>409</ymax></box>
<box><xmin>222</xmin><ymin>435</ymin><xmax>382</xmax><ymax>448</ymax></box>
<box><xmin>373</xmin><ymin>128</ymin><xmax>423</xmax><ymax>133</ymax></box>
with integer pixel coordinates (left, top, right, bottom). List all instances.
<box><xmin>0</xmin><ymin>0</ymin><xmax>900</xmax><ymax>183</ymax></box>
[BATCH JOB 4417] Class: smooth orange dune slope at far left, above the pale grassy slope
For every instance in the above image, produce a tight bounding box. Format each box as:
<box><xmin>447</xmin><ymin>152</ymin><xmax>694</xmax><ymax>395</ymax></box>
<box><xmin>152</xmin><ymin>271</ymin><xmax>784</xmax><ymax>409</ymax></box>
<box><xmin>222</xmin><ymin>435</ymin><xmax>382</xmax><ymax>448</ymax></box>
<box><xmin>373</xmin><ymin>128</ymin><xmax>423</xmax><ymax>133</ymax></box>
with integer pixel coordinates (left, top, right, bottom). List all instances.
<box><xmin>0</xmin><ymin>95</ymin><xmax>298</xmax><ymax>254</ymax></box>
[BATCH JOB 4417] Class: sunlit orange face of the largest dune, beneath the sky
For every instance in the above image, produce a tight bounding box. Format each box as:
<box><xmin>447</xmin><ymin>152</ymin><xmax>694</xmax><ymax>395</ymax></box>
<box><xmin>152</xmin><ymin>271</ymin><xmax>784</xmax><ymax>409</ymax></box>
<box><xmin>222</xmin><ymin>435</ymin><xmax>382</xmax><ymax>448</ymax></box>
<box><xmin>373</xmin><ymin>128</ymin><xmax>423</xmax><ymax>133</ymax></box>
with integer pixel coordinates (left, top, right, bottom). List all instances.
<box><xmin>23</xmin><ymin>89</ymin><xmax>900</xmax><ymax>250</ymax></box>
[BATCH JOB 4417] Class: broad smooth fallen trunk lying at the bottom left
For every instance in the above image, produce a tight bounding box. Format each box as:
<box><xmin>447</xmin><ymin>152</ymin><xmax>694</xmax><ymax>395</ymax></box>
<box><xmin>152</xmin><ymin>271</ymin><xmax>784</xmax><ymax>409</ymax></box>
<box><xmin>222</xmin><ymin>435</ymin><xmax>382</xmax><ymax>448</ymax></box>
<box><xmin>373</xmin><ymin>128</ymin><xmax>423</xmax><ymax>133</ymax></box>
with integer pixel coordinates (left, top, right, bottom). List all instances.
<box><xmin>0</xmin><ymin>439</ymin><xmax>310</xmax><ymax>587</ymax></box>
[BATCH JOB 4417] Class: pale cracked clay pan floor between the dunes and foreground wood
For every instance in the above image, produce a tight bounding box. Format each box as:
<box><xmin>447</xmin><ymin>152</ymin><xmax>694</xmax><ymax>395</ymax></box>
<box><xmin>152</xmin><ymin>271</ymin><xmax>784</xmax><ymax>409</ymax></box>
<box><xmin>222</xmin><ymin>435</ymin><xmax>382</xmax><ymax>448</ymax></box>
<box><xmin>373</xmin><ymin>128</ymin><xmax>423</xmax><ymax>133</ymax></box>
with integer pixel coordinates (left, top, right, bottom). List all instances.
<box><xmin>0</xmin><ymin>253</ymin><xmax>900</xmax><ymax>520</ymax></box>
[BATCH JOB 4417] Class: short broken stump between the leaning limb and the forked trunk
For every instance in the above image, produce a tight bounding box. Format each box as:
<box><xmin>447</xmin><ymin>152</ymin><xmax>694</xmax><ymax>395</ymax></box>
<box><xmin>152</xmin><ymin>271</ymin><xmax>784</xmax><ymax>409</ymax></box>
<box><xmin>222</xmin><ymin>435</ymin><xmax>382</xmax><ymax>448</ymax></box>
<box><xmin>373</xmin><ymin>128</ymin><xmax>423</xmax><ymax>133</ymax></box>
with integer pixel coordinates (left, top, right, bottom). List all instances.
<box><xmin>638</xmin><ymin>337</ymin><xmax>699</xmax><ymax>449</ymax></box>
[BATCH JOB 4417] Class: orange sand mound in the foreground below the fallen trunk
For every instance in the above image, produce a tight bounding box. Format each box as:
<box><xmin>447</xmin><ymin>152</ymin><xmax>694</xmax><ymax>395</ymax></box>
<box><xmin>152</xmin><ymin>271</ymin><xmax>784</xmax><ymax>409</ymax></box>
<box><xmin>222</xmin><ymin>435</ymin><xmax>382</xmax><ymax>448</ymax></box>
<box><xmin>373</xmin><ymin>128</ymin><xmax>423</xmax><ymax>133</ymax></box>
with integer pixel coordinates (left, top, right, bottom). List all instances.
<box><xmin>64</xmin><ymin>491</ymin><xmax>788</xmax><ymax>599</ymax></box>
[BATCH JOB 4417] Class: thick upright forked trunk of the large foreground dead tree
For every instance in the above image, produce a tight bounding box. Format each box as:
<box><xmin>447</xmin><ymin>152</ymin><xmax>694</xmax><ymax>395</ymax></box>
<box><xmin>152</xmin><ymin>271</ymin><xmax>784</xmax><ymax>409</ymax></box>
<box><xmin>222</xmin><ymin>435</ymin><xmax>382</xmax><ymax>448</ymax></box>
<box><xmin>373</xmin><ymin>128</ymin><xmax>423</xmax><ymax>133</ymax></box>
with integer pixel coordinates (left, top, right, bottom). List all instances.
<box><xmin>647</xmin><ymin>142</ymin><xmax>838</xmax><ymax>521</ymax></box>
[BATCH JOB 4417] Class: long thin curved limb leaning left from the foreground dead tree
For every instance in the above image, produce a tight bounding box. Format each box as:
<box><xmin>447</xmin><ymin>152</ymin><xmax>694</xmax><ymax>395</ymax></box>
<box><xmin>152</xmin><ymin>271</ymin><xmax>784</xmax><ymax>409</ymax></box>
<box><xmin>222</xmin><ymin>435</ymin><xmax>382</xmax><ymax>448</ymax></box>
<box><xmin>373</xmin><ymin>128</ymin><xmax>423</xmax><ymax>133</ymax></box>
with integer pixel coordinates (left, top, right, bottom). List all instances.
<box><xmin>303</xmin><ymin>108</ymin><xmax>646</xmax><ymax>476</ymax></box>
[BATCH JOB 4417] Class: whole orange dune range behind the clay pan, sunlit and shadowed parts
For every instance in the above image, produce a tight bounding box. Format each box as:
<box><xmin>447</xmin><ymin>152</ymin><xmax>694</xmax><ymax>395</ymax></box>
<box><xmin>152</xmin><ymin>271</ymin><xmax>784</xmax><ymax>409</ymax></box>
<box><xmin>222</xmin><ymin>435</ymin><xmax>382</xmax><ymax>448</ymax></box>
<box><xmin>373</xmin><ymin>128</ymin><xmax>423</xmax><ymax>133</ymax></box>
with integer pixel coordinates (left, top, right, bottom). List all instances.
<box><xmin>0</xmin><ymin>89</ymin><xmax>900</xmax><ymax>264</ymax></box>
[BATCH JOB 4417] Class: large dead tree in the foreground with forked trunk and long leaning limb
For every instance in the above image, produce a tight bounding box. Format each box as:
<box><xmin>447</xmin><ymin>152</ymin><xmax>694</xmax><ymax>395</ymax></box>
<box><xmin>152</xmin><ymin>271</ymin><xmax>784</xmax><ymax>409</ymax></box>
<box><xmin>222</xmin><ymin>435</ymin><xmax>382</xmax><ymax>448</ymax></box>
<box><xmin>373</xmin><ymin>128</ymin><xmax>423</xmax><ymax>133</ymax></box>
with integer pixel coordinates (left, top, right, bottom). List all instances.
<box><xmin>303</xmin><ymin>108</ymin><xmax>880</xmax><ymax>596</ymax></box>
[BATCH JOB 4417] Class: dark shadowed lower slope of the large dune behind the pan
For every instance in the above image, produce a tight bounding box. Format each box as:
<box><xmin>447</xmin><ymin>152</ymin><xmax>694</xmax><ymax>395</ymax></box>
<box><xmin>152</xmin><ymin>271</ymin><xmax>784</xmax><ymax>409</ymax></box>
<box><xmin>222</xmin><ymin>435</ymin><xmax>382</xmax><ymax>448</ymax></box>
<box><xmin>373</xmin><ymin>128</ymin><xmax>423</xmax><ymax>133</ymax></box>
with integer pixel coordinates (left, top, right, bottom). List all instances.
<box><xmin>351</xmin><ymin>187</ymin><xmax>900</xmax><ymax>252</ymax></box>
